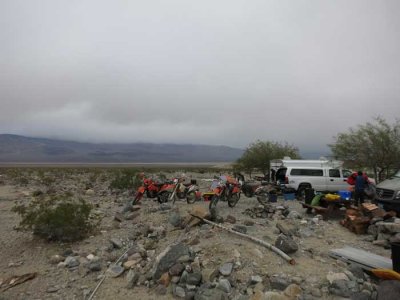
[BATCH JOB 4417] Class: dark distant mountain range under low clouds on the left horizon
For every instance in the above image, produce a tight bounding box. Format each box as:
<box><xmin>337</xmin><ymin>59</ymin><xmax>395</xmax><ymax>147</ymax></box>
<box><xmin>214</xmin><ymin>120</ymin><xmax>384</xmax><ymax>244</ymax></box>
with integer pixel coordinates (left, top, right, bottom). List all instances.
<box><xmin>0</xmin><ymin>134</ymin><xmax>244</xmax><ymax>163</ymax></box>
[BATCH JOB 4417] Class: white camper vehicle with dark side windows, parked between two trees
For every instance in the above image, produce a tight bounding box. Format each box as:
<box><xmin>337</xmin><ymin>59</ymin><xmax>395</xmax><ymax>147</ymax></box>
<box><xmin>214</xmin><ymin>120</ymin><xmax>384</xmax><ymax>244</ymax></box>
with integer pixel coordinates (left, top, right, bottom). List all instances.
<box><xmin>273</xmin><ymin>159</ymin><xmax>352</xmax><ymax>196</ymax></box>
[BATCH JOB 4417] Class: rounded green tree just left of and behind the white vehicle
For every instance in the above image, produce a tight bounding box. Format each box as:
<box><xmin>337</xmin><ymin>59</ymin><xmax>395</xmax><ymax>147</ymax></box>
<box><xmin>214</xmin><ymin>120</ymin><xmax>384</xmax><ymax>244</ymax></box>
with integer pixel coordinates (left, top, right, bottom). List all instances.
<box><xmin>234</xmin><ymin>140</ymin><xmax>300</xmax><ymax>178</ymax></box>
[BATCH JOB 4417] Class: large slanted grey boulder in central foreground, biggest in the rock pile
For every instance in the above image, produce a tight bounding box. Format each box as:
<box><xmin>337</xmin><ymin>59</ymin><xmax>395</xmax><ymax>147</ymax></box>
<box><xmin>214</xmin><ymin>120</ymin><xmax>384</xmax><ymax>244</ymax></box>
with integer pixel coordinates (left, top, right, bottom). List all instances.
<box><xmin>152</xmin><ymin>243</ymin><xmax>190</xmax><ymax>280</ymax></box>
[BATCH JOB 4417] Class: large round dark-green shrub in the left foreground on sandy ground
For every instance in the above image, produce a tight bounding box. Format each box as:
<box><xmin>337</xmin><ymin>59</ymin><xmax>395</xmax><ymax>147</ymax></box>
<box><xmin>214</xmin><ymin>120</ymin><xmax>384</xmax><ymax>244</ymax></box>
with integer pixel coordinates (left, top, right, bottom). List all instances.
<box><xmin>13</xmin><ymin>196</ymin><xmax>94</xmax><ymax>242</ymax></box>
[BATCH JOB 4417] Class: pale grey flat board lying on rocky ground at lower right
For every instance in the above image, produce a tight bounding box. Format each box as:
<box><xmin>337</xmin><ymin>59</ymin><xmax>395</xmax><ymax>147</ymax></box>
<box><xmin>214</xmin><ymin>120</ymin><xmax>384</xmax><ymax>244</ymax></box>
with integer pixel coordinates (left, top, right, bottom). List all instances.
<box><xmin>329</xmin><ymin>246</ymin><xmax>392</xmax><ymax>271</ymax></box>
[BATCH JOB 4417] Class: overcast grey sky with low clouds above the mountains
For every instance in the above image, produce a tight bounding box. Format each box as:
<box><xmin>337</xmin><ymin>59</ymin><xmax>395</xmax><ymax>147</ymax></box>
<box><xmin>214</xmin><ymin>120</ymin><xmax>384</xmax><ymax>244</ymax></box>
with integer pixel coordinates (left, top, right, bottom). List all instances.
<box><xmin>0</xmin><ymin>0</ymin><xmax>400</xmax><ymax>155</ymax></box>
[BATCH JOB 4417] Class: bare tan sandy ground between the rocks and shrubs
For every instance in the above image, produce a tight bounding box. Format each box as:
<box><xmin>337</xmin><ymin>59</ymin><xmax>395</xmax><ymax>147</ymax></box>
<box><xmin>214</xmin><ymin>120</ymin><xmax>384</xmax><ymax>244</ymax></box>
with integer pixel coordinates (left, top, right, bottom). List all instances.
<box><xmin>0</xmin><ymin>169</ymin><xmax>390</xmax><ymax>299</ymax></box>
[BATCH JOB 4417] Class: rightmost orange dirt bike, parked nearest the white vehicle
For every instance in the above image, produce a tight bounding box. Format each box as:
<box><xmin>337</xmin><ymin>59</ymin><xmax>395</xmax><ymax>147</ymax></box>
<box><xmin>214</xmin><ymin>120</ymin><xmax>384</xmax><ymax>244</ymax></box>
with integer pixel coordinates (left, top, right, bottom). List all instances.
<box><xmin>209</xmin><ymin>176</ymin><xmax>241</xmax><ymax>210</ymax></box>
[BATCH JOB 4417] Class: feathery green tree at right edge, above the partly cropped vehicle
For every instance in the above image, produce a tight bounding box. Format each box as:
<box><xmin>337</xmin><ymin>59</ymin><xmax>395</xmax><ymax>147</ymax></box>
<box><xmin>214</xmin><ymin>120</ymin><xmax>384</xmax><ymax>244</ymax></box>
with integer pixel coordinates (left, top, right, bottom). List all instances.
<box><xmin>328</xmin><ymin>117</ymin><xmax>400</xmax><ymax>182</ymax></box>
